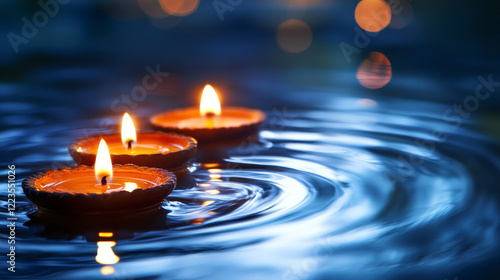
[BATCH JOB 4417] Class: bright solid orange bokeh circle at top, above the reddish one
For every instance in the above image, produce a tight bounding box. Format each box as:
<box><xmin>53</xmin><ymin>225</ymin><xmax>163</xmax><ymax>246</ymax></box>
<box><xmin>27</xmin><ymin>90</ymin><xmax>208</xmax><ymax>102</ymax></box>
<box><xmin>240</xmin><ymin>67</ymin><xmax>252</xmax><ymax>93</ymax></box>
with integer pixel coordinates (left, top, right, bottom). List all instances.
<box><xmin>354</xmin><ymin>0</ymin><xmax>391</xmax><ymax>32</ymax></box>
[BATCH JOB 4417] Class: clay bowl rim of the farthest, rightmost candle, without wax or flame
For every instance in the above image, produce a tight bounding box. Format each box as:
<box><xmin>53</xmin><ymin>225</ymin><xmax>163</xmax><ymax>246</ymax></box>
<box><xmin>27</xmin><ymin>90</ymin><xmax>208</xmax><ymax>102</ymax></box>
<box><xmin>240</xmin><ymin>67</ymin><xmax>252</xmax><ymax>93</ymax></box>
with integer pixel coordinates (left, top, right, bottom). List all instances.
<box><xmin>149</xmin><ymin>107</ymin><xmax>266</xmax><ymax>142</ymax></box>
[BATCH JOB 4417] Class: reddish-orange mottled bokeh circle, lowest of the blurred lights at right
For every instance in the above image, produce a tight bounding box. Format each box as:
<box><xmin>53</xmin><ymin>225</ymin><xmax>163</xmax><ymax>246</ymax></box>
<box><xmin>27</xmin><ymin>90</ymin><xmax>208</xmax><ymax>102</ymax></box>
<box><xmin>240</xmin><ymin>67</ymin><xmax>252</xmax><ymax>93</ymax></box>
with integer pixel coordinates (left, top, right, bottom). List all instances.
<box><xmin>356</xmin><ymin>52</ymin><xmax>392</xmax><ymax>89</ymax></box>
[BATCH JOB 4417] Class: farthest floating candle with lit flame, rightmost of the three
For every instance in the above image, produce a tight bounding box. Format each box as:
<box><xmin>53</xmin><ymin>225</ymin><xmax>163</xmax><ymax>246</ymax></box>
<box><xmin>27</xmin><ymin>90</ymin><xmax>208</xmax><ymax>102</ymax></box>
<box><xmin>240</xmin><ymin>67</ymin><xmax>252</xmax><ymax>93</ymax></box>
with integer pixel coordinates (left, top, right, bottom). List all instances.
<box><xmin>150</xmin><ymin>85</ymin><xmax>266</xmax><ymax>142</ymax></box>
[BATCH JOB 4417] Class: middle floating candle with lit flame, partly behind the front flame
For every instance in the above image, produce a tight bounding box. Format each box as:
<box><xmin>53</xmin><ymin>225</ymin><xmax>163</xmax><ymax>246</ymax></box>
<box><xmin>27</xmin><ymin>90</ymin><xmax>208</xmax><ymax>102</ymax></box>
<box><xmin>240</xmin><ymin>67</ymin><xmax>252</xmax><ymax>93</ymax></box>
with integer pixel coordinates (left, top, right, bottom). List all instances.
<box><xmin>68</xmin><ymin>113</ymin><xmax>198</xmax><ymax>169</ymax></box>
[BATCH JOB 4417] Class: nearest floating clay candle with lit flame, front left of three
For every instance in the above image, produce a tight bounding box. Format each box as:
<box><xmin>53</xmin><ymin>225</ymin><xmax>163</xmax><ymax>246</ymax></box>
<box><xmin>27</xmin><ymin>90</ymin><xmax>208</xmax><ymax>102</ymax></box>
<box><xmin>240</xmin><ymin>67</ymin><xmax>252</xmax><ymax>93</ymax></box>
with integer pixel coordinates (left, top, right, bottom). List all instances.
<box><xmin>23</xmin><ymin>140</ymin><xmax>176</xmax><ymax>213</ymax></box>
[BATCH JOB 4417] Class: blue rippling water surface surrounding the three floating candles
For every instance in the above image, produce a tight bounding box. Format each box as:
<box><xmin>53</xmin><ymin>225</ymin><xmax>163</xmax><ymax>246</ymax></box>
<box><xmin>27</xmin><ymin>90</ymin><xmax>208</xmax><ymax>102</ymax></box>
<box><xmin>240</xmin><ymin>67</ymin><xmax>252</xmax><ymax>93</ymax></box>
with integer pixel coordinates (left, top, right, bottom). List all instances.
<box><xmin>0</xmin><ymin>80</ymin><xmax>500</xmax><ymax>279</ymax></box>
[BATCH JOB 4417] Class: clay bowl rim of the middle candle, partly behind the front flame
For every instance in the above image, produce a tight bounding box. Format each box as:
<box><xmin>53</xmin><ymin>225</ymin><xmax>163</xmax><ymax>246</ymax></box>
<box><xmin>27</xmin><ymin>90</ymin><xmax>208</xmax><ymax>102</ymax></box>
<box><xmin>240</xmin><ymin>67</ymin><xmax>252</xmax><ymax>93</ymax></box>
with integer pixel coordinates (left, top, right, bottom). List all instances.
<box><xmin>68</xmin><ymin>131</ymin><xmax>198</xmax><ymax>169</ymax></box>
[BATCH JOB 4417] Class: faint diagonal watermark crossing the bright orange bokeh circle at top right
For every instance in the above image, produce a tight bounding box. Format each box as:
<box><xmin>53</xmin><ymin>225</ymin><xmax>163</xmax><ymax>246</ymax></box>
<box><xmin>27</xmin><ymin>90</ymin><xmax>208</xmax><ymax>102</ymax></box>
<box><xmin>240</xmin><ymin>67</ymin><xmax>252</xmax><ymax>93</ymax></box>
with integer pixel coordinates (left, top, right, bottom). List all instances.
<box><xmin>339</xmin><ymin>0</ymin><xmax>412</xmax><ymax>63</ymax></box>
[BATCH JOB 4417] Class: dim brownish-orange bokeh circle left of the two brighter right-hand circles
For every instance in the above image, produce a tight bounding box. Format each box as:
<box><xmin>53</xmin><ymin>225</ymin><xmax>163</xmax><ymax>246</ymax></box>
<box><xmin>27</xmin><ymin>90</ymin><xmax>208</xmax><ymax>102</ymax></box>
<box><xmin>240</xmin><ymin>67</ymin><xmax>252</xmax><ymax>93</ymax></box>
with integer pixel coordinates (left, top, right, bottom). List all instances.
<box><xmin>276</xmin><ymin>19</ymin><xmax>312</xmax><ymax>53</ymax></box>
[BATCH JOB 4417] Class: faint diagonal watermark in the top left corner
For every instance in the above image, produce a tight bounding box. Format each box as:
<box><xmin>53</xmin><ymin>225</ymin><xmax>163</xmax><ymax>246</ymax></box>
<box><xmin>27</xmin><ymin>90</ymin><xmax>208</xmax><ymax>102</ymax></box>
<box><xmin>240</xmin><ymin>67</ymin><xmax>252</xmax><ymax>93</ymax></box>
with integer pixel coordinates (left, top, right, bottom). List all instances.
<box><xmin>7</xmin><ymin>0</ymin><xmax>70</xmax><ymax>54</ymax></box>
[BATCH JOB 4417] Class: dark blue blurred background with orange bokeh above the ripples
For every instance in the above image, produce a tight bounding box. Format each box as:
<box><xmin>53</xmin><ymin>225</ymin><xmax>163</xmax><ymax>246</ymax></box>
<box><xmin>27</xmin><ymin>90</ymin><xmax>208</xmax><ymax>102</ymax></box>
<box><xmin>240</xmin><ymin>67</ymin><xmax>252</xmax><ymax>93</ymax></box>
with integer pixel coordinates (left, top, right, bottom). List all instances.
<box><xmin>0</xmin><ymin>0</ymin><xmax>500</xmax><ymax>123</ymax></box>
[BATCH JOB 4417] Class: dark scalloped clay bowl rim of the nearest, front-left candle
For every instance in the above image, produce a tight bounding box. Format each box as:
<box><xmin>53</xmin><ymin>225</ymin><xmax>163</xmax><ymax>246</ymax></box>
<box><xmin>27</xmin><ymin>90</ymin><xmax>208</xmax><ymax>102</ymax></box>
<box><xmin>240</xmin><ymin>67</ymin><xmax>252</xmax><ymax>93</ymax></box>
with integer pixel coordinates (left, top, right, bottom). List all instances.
<box><xmin>22</xmin><ymin>164</ymin><xmax>177</xmax><ymax>213</ymax></box>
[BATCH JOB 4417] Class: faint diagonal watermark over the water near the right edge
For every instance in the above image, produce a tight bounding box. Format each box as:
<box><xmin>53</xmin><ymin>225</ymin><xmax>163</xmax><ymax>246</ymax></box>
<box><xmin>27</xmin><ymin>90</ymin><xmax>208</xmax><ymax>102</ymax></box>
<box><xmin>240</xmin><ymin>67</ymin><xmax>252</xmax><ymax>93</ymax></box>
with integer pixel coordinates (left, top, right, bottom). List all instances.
<box><xmin>386</xmin><ymin>74</ymin><xmax>500</xmax><ymax>184</ymax></box>
